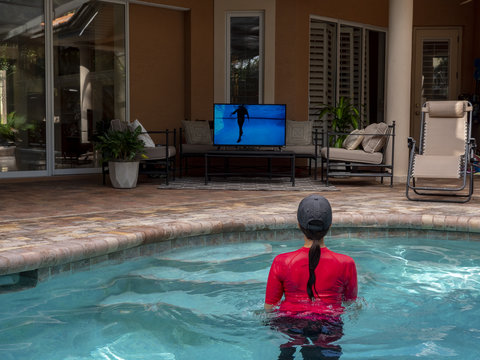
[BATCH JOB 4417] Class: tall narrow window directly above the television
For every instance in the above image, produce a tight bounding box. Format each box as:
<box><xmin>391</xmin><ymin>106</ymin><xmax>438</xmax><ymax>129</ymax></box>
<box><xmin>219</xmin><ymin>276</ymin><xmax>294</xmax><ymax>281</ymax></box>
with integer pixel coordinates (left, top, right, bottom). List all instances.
<box><xmin>227</xmin><ymin>12</ymin><xmax>263</xmax><ymax>104</ymax></box>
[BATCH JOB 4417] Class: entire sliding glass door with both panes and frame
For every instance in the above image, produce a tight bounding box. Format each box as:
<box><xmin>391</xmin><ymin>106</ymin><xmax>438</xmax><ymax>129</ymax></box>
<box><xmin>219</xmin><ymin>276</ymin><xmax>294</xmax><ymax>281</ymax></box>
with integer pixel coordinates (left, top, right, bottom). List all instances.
<box><xmin>0</xmin><ymin>0</ymin><xmax>126</xmax><ymax>178</ymax></box>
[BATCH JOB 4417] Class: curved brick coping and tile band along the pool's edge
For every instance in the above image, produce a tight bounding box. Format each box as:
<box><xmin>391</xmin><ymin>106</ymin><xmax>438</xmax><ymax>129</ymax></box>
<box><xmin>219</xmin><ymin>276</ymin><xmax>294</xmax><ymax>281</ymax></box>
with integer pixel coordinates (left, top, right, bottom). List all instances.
<box><xmin>0</xmin><ymin>213</ymin><xmax>480</xmax><ymax>281</ymax></box>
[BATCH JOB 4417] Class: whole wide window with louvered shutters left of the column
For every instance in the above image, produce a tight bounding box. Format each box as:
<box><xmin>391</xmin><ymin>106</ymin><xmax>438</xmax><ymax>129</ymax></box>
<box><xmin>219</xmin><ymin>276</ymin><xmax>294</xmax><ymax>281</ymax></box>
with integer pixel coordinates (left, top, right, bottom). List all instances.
<box><xmin>309</xmin><ymin>18</ymin><xmax>386</xmax><ymax>141</ymax></box>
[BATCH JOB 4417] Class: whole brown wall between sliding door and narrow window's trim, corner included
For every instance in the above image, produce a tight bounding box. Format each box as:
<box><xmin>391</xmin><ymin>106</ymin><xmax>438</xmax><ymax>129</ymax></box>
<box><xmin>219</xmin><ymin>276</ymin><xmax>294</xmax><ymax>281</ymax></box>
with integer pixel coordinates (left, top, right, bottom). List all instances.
<box><xmin>129</xmin><ymin>0</ymin><xmax>213</xmax><ymax>130</ymax></box>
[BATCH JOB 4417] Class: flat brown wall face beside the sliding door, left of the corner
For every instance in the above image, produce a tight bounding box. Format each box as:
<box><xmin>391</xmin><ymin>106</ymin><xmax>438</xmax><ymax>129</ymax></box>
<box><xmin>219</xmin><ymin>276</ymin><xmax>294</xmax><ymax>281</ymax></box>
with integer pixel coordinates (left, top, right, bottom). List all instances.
<box><xmin>130</xmin><ymin>5</ymin><xmax>185</xmax><ymax>134</ymax></box>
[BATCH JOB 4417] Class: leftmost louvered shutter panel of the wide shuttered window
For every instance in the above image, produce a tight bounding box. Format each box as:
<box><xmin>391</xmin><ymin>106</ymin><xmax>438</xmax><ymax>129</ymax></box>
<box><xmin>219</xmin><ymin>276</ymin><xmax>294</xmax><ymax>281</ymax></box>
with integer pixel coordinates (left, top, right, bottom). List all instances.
<box><xmin>308</xmin><ymin>19</ymin><xmax>336</xmax><ymax>142</ymax></box>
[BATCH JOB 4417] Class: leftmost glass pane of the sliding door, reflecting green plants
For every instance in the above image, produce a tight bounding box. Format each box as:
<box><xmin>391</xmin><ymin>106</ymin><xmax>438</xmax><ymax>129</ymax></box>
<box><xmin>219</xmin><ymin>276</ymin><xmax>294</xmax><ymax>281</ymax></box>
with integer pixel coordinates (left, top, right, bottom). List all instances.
<box><xmin>0</xmin><ymin>0</ymin><xmax>46</xmax><ymax>176</ymax></box>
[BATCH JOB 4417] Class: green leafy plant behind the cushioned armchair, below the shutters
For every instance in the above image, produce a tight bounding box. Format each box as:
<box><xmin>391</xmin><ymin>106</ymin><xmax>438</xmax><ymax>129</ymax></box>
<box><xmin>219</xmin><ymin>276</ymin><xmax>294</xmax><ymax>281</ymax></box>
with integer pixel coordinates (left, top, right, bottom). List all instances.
<box><xmin>319</xmin><ymin>96</ymin><xmax>360</xmax><ymax>147</ymax></box>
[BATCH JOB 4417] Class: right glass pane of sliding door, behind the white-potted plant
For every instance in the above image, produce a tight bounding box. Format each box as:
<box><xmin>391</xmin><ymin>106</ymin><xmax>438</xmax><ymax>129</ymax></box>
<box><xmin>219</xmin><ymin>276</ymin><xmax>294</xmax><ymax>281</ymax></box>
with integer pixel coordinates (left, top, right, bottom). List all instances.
<box><xmin>53</xmin><ymin>0</ymin><xmax>126</xmax><ymax>170</ymax></box>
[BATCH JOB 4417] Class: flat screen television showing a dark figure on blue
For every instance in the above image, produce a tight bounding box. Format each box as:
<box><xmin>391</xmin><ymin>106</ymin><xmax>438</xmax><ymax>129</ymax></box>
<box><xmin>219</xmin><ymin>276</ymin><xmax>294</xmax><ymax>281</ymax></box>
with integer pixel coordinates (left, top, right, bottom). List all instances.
<box><xmin>213</xmin><ymin>104</ymin><xmax>286</xmax><ymax>146</ymax></box>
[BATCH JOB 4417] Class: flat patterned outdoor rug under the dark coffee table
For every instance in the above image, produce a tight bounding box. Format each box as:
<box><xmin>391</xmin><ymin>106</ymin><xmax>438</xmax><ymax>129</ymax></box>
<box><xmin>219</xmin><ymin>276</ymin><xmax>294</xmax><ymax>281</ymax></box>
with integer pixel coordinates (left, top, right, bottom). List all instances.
<box><xmin>158</xmin><ymin>176</ymin><xmax>337</xmax><ymax>191</ymax></box>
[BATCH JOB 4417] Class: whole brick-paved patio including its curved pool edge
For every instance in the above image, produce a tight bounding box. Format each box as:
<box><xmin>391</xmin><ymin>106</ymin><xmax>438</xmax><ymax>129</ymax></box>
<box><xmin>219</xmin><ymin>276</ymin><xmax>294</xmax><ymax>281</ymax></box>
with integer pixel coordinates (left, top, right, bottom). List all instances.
<box><xmin>0</xmin><ymin>175</ymin><xmax>480</xmax><ymax>277</ymax></box>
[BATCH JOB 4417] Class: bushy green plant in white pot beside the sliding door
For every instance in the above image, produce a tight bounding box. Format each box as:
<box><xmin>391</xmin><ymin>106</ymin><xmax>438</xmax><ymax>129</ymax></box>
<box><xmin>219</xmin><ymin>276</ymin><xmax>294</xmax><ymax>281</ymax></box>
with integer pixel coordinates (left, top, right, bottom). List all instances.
<box><xmin>95</xmin><ymin>126</ymin><xmax>145</xmax><ymax>189</ymax></box>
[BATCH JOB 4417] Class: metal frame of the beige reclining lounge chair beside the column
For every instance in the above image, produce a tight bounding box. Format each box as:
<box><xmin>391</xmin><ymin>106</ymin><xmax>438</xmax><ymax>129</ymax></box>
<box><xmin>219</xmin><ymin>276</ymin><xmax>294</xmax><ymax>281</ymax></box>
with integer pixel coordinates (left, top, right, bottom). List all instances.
<box><xmin>406</xmin><ymin>101</ymin><xmax>476</xmax><ymax>203</ymax></box>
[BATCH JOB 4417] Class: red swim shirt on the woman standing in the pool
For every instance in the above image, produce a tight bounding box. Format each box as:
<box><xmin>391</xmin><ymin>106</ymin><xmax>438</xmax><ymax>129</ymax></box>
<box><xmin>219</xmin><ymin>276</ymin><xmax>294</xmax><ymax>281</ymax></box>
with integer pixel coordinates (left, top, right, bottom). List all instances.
<box><xmin>265</xmin><ymin>247</ymin><xmax>357</xmax><ymax>315</ymax></box>
